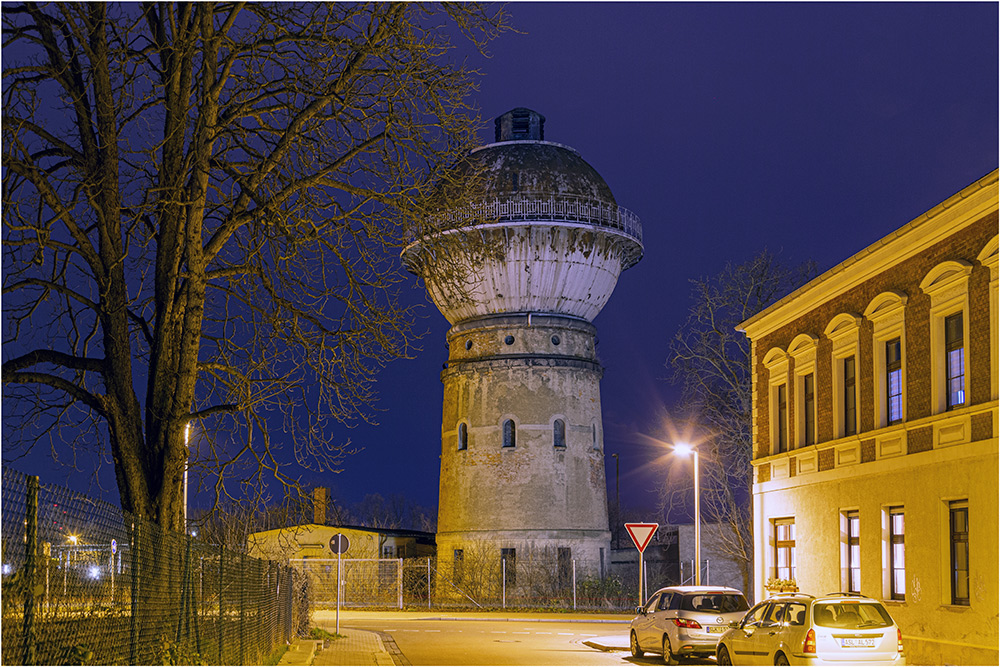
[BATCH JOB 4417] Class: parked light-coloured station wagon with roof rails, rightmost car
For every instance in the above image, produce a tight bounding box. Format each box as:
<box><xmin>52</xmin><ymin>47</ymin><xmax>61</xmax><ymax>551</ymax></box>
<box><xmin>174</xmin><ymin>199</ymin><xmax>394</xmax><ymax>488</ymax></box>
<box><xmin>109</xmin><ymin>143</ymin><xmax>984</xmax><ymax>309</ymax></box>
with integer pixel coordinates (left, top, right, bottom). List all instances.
<box><xmin>716</xmin><ymin>593</ymin><xmax>906</xmax><ymax>665</ymax></box>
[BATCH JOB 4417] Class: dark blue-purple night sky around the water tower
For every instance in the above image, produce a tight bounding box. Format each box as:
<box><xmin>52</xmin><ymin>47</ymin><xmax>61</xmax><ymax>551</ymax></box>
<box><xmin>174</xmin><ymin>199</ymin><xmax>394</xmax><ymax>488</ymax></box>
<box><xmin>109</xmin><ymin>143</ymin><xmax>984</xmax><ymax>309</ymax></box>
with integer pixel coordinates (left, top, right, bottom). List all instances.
<box><xmin>14</xmin><ymin>3</ymin><xmax>998</xmax><ymax>520</ymax></box>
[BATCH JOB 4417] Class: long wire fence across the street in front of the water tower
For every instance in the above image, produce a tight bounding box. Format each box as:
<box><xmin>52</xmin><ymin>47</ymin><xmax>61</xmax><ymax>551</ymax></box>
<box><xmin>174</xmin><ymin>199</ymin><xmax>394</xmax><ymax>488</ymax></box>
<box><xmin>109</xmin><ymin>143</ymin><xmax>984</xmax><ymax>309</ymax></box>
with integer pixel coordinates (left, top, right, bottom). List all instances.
<box><xmin>289</xmin><ymin>558</ymin><xmax>635</xmax><ymax>611</ymax></box>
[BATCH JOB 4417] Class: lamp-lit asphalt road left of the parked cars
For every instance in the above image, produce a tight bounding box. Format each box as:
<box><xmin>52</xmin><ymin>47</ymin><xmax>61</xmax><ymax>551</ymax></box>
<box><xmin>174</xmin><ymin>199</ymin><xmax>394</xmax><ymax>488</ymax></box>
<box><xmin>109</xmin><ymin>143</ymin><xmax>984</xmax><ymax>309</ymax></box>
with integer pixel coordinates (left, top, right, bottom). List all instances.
<box><xmin>344</xmin><ymin>618</ymin><xmax>632</xmax><ymax>666</ymax></box>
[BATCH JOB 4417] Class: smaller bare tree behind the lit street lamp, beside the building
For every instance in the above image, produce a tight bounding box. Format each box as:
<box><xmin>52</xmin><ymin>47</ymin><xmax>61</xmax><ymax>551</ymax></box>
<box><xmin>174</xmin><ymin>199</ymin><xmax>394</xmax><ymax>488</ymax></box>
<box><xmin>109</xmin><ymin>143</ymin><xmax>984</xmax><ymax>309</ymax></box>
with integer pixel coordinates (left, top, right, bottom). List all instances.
<box><xmin>660</xmin><ymin>249</ymin><xmax>816</xmax><ymax>590</ymax></box>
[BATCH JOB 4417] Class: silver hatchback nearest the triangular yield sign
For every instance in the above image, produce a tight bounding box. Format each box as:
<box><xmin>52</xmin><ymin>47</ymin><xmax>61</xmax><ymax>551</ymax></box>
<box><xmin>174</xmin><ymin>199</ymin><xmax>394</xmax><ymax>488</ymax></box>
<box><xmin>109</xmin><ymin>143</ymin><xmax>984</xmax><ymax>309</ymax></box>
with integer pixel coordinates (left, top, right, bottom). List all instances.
<box><xmin>629</xmin><ymin>586</ymin><xmax>750</xmax><ymax>665</ymax></box>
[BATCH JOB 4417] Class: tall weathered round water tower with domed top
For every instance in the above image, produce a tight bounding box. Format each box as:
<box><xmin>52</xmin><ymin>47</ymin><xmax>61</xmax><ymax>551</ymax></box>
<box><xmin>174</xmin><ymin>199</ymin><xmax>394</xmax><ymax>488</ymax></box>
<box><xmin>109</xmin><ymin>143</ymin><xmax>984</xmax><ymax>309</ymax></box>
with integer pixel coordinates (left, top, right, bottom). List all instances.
<box><xmin>403</xmin><ymin>108</ymin><xmax>642</xmax><ymax>579</ymax></box>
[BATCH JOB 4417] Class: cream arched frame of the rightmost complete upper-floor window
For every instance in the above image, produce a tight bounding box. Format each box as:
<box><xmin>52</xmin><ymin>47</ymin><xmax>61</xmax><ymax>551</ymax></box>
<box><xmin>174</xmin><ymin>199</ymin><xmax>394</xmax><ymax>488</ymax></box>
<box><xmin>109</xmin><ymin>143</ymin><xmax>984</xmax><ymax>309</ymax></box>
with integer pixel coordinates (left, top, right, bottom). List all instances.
<box><xmin>920</xmin><ymin>259</ymin><xmax>973</xmax><ymax>414</ymax></box>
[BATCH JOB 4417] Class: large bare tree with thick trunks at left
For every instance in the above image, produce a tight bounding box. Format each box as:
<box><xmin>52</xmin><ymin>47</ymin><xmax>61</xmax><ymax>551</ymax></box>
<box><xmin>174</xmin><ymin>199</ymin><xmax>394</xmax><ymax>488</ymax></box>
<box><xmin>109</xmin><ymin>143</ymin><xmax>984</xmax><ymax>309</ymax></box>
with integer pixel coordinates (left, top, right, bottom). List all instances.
<box><xmin>3</xmin><ymin>3</ymin><xmax>506</xmax><ymax>530</ymax></box>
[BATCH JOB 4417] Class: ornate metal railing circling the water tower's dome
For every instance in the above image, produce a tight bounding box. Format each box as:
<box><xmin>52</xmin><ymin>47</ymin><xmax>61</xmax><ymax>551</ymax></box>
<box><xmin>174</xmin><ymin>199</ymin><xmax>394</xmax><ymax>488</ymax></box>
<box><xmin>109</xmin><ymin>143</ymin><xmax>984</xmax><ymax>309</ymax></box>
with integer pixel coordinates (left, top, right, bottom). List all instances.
<box><xmin>433</xmin><ymin>195</ymin><xmax>642</xmax><ymax>244</ymax></box>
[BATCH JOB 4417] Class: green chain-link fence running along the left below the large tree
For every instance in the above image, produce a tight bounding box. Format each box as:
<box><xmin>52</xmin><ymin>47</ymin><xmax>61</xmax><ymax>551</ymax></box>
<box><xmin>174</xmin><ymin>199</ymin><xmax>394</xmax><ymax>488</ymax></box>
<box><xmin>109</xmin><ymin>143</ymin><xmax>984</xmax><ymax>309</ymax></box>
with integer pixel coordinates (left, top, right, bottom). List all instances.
<box><xmin>2</xmin><ymin>468</ymin><xmax>308</xmax><ymax>665</ymax></box>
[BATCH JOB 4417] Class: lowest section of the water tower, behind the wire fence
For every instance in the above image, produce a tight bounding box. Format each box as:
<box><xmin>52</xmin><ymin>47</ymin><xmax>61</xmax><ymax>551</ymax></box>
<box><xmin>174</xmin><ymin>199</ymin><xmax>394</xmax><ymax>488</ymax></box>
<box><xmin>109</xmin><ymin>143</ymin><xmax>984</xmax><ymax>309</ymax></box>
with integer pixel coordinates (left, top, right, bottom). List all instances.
<box><xmin>436</xmin><ymin>529</ymin><xmax>611</xmax><ymax>606</ymax></box>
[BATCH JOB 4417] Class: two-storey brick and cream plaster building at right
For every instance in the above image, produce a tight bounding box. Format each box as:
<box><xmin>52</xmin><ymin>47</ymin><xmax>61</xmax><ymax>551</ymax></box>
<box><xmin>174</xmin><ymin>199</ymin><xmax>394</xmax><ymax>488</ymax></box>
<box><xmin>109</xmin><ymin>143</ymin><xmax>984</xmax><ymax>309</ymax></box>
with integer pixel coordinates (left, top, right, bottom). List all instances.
<box><xmin>741</xmin><ymin>171</ymin><xmax>998</xmax><ymax>664</ymax></box>
